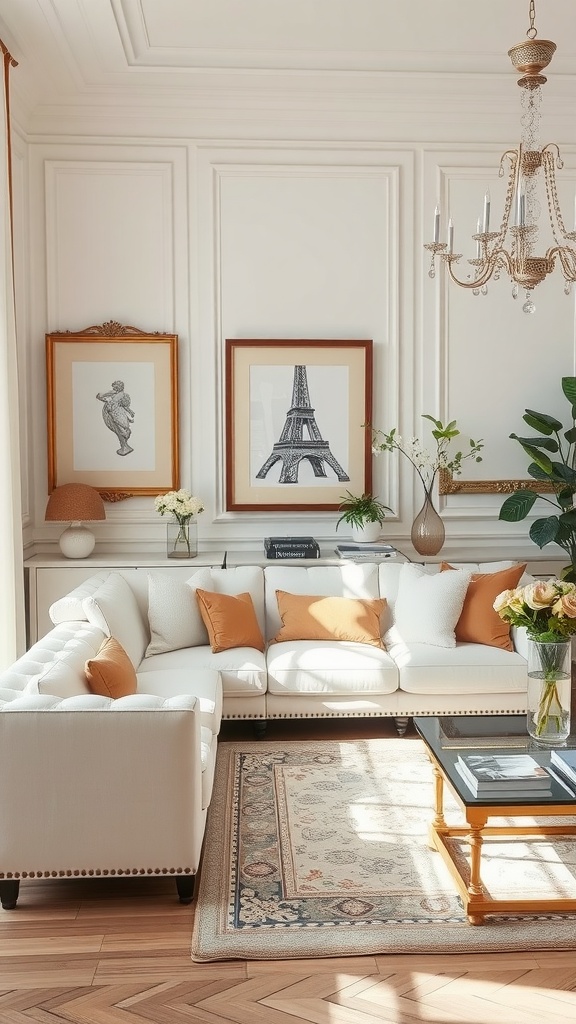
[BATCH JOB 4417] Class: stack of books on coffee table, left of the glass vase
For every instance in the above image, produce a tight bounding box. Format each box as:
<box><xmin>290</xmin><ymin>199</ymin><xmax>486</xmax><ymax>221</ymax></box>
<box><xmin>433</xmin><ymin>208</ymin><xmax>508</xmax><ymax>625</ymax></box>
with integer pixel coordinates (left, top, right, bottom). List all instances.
<box><xmin>456</xmin><ymin>754</ymin><xmax>551</xmax><ymax>799</ymax></box>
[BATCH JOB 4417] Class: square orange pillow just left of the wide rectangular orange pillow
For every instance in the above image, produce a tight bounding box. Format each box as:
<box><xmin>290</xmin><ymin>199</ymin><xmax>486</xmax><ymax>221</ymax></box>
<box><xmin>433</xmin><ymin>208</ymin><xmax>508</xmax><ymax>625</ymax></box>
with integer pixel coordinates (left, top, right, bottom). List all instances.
<box><xmin>196</xmin><ymin>589</ymin><xmax>264</xmax><ymax>654</ymax></box>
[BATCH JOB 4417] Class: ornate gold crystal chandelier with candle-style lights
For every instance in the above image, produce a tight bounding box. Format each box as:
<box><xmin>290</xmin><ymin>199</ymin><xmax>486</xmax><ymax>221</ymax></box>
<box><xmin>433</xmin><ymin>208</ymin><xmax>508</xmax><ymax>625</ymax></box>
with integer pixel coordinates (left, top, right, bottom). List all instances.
<box><xmin>424</xmin><ymin>0</ymin><xmax>576</xmax><ymax>313</ymax></box>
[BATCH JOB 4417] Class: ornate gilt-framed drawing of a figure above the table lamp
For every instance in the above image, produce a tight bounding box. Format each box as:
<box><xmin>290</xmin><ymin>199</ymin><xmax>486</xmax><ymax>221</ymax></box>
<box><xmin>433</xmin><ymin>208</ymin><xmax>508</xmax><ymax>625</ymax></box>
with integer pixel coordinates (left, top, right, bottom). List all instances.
<box><xmin>46</xmin><ymin>321</ymin><xmax>179</xmax><ymax>501</ymax></box>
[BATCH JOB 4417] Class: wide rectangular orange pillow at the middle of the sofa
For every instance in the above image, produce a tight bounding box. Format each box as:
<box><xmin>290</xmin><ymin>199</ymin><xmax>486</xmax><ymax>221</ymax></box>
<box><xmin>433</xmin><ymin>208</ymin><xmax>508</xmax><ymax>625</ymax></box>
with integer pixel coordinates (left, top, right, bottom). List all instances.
<box><xmin>274</xmin><ymin>590</ymin><xmax>386</xmax><ymax>647</ymax></box>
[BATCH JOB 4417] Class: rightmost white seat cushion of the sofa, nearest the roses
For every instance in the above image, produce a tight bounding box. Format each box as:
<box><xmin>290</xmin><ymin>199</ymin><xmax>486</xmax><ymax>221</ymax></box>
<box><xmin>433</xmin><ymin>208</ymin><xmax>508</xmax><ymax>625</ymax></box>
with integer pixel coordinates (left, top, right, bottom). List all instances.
<box><xmin>387</xmin><ymin>640</ymin><xmax>527</xmax><ymax>695</ymax></box>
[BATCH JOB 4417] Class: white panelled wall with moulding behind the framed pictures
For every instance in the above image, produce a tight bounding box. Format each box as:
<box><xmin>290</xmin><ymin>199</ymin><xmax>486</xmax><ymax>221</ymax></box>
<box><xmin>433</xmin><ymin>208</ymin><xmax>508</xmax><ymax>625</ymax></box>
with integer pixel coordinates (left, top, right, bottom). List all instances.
<box><xmin>14</xmin><ymin>95</ymin><xmax>576</xmax><ymax>551</ymax></box>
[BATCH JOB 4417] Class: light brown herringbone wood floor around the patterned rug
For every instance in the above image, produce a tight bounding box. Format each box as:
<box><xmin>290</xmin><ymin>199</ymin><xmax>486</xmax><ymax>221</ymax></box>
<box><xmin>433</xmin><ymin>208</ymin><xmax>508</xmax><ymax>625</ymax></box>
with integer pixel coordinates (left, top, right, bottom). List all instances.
<box><xmin>0</xmin><ymin>721</ymin><xmax>576</xmax><ymax>1024</ymax></box>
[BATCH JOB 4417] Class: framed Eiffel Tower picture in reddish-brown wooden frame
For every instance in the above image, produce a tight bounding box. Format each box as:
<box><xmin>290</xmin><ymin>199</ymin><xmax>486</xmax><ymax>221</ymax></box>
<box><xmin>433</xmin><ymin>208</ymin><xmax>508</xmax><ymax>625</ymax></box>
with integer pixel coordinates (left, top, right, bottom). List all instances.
<box><xmin>225</xmin><ymin>339</ymin><xmax>372</xmax><ymax>512</ymax></box>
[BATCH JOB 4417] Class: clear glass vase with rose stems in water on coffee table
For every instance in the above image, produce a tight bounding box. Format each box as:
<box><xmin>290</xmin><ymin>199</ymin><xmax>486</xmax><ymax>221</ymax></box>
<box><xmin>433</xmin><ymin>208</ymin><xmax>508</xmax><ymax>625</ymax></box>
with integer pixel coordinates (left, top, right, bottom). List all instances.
<box><xmin>526</xmin><ymin>638</ymin><xmax>572</xmax><ymax>746</ymax></box>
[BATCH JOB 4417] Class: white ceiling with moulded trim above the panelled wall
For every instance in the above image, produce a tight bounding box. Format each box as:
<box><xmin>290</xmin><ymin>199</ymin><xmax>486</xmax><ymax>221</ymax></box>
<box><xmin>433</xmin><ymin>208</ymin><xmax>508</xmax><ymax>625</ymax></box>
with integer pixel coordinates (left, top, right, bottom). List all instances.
<box><xmin>0</xmin><ymin>0</ymin><xmax>576</xmax><ymax>132</ymax></box>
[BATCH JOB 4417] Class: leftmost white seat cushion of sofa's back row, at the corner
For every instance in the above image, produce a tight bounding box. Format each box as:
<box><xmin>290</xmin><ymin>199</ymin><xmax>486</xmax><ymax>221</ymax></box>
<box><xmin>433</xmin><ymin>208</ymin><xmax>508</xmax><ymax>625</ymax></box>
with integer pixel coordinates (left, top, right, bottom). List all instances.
<box><xmin>137</xmin><ymin>646</ymin><xmax>266</xmax><ymax>697</ymax></box>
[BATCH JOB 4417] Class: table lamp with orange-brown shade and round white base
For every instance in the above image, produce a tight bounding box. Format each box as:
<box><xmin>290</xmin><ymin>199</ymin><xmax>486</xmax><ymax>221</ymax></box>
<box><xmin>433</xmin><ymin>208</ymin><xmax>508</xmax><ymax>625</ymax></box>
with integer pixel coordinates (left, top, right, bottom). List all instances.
<box><xmin>44</xmin><ymin>483</ymin><xmax>106</xmax><ymax>558</ymax></box>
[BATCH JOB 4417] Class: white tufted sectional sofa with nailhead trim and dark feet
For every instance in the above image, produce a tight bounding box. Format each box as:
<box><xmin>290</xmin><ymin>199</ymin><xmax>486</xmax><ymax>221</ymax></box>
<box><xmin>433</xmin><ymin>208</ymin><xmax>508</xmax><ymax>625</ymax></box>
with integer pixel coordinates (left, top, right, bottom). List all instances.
<box><xmin>0</xmin><ymin>561</ymin><xmax>527</xmax><ymax>908</ymax></box>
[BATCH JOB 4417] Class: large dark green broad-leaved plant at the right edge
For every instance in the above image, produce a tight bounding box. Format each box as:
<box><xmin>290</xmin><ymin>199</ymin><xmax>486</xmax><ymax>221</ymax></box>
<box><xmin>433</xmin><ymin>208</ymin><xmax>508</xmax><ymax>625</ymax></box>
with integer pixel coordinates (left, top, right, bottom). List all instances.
<box><xmin>499</xmin><ymin>377</ymin><xmax>576</xmax><ymax>583</ymax></box>
